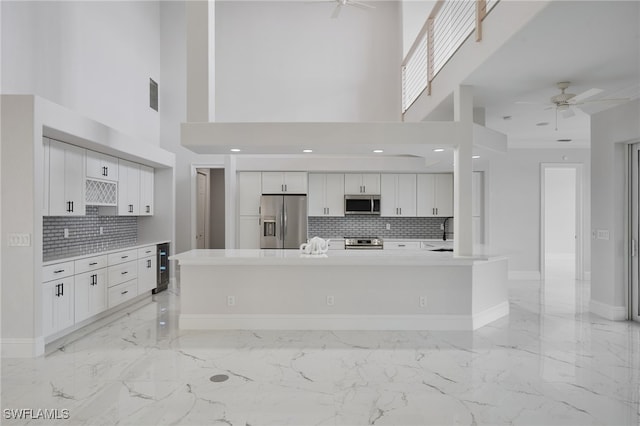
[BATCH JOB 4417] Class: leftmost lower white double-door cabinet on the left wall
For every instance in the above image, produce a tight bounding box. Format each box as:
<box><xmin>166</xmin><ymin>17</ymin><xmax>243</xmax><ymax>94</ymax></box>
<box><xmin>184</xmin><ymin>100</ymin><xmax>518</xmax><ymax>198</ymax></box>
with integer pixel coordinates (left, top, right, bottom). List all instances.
<box><xmin>42</xmin><ymin>276</ymin><xmax>74</xmax><ymax>337</ymax></box>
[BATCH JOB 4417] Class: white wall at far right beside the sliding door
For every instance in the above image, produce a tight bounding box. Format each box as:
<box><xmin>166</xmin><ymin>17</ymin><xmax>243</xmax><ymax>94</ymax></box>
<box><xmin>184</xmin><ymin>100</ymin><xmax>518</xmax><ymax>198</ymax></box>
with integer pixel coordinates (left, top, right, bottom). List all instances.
<box><xmin>591</xmin><ymin>100</ymin><xmax>640</xmax><ymax>319</ymax></box>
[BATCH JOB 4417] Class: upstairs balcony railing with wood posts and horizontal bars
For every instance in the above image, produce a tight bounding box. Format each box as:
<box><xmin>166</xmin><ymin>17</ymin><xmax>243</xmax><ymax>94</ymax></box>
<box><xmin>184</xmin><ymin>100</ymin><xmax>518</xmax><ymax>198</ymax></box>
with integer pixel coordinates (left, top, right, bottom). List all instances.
<box><xmin>402</xmin><ymin>0</ymin><xmax>499</xmax><ymax>114</ymax></box>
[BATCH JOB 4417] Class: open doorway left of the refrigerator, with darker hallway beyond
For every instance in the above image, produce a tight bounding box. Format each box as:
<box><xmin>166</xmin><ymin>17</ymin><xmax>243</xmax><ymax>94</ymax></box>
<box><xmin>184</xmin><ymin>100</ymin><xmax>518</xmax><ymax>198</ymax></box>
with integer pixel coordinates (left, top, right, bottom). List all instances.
<box><xmin>195</xmin><ymin>167</ymin><xmax>225</xmax><ymax>249</ymax></box>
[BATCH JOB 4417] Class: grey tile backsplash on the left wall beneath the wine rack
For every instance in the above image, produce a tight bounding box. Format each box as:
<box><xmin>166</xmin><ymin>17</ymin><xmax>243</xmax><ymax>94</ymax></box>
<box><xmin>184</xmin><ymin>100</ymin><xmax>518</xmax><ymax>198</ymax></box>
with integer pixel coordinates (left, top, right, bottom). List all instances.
<box><xmin>42</xmin><ymin>206</ymin><xmax>138</xmax><ymax>262</ymax></box>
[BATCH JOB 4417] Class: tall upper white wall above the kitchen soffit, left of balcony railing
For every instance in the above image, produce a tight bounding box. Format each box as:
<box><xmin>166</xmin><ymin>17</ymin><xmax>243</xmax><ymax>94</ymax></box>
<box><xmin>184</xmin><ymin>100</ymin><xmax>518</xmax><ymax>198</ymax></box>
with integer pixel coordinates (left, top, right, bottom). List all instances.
<box><xmin>215</xmin><ymin>1</ymin><xmax>402</xmax><ymax>122</ymax></box>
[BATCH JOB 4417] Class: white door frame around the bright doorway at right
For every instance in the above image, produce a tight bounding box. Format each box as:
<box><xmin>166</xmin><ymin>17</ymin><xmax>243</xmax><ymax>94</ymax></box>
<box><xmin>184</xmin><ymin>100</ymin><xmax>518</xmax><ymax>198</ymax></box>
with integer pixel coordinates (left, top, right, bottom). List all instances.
<box><xmin>540</xmin><ymin>163</ymin><xmax>584</xmax><ymax>280</ymax></box>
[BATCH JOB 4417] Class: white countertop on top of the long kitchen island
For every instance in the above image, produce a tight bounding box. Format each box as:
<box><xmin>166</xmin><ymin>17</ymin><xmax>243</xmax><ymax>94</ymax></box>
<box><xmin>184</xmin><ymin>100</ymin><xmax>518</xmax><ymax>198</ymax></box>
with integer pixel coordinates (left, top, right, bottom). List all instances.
<box><xmin>169</xmin><ymin>249</ymin><xmax>505</xmax><ymax>266</ymax></box>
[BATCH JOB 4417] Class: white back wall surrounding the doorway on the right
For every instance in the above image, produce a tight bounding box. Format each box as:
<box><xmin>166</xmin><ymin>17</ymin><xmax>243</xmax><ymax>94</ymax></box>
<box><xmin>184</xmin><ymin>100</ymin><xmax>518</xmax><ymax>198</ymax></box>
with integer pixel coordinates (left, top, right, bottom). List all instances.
<box><xmin>486</xmin><ymin>149</ymin><xmax>590</xmax><ymax>279</ymax></box>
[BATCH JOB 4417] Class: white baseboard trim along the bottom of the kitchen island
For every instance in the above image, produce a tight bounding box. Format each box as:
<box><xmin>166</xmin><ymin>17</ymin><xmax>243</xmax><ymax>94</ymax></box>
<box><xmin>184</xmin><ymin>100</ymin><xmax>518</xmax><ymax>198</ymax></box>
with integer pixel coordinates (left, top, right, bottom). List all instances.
<box><xmin>180</xmin><ymin>302</ymin><xmax>509</xmax><ymax>331</ymax></box>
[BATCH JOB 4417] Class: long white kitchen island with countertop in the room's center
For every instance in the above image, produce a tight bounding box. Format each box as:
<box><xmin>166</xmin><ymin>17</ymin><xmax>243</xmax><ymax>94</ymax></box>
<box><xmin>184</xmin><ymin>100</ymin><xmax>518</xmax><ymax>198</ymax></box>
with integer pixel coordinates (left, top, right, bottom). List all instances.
<box><xmin>170</xmin><ymin>250</ymin><xmax>509</xmax><ymax>330</ymax></box>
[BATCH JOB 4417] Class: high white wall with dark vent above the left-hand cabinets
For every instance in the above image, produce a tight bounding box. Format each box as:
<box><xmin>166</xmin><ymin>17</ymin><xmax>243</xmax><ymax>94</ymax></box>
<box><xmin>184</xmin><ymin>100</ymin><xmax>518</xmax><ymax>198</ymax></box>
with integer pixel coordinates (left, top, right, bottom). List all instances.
<box><xmin>1</xmin><ymin>1</ymin><xmax>163</xmax><ymax>146</ymax></box>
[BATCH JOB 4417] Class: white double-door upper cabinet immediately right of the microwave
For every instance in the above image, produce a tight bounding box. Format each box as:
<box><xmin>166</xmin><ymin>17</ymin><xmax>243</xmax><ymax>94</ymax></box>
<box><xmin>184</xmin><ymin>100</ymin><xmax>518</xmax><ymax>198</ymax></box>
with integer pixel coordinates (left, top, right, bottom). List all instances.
<box><xmin>380</xmin><ymin>174</ymin><xmax>416</xmax><ymax>216</ymax></box>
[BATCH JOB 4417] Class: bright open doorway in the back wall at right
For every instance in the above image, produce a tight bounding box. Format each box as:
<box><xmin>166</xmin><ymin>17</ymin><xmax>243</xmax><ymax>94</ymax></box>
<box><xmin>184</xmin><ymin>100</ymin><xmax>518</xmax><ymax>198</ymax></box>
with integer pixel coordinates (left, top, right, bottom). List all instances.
<box><xmin>540</xmin><ymin>164</ymin><xmax>584</xmax><ymax>281</ymax></box>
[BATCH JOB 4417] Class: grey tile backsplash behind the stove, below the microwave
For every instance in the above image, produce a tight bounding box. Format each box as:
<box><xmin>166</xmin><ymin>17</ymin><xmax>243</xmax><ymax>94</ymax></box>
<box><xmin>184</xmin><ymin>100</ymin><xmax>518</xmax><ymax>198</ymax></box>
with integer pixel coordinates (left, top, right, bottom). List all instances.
<box><xmin>307</xmin><ymin>215</ymin><xmax>453</xmax><ymax>239</ymax></box>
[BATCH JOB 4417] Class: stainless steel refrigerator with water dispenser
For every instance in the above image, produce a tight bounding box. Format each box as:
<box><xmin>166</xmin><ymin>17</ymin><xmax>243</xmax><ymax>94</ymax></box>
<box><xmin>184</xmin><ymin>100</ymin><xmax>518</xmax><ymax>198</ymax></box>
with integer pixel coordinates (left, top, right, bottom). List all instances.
<box><xmin>260</xmin><ymin>195</ymin><xmax>307</xmax><ymax>249</ymax></box>
